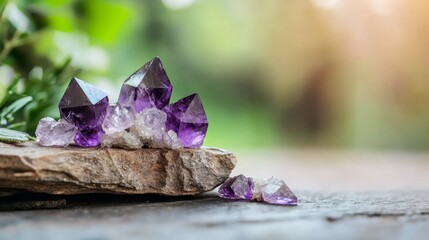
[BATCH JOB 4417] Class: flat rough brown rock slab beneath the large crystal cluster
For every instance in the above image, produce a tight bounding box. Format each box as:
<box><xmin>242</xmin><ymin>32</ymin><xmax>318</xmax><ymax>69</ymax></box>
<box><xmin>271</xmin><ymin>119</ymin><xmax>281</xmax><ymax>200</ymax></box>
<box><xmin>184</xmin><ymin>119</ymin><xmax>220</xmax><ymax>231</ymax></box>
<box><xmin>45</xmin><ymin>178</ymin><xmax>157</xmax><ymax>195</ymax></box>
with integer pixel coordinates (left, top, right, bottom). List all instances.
<box><xmin>0</xmin><ymin>143</ymin><xmax>236</xmax><ymax>196</ymax></box>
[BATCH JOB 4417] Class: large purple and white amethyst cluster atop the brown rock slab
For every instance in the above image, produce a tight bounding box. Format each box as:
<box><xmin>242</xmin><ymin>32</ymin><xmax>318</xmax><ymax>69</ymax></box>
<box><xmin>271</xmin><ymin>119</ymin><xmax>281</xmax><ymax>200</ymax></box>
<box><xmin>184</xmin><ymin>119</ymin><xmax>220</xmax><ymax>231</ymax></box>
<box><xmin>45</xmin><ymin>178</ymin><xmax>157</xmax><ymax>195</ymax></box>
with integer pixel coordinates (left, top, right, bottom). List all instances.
<box><xmin>36</xmin><ymin>57</ymin><xmax>208</xmax><ymax>148</ymax></box>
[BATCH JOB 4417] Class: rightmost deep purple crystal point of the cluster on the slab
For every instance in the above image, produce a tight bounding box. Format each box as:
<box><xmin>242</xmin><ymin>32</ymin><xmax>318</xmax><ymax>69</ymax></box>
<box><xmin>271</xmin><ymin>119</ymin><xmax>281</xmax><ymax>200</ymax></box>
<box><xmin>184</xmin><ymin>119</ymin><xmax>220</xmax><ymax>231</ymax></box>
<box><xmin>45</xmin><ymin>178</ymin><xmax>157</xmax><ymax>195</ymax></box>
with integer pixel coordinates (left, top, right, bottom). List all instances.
<box><xmin>164</xmin><ymin>93</ymin><xmax>209</xmax><ymax>148</ymax></box>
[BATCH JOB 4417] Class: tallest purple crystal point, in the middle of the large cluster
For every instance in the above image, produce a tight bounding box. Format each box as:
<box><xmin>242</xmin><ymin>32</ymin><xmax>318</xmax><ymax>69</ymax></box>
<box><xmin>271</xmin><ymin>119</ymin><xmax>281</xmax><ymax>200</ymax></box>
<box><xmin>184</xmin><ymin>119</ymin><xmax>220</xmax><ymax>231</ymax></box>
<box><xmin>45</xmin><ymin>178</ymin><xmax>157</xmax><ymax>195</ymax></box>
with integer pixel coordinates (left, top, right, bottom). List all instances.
<box><xmin>118</xmin><ymin>57</ymin><xmax>173</xmax><ymax>112</ymax></box>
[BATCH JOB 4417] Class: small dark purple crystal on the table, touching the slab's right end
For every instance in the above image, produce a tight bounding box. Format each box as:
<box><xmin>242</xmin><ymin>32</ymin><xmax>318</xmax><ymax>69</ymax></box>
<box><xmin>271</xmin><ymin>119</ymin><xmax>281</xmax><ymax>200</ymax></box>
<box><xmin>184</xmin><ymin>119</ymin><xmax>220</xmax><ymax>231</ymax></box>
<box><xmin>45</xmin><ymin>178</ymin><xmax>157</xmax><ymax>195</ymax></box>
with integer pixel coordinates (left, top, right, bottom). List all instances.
<box><xmin>219</xmin><ymin>174</ymin><xmax>255</xmax><ymax>200</ymax></box>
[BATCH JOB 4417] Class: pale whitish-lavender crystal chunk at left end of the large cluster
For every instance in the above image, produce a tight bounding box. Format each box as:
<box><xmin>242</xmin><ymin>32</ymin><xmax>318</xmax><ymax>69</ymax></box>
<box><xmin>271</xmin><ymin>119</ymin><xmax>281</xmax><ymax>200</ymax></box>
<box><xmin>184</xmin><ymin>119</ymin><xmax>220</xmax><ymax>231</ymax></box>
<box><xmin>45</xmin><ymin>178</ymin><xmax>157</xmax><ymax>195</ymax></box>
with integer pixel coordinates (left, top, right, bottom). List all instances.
<box><xmin>36</xmin><ymin>117</ymin><xmax>77</xmax><ymax>147</ymax></box>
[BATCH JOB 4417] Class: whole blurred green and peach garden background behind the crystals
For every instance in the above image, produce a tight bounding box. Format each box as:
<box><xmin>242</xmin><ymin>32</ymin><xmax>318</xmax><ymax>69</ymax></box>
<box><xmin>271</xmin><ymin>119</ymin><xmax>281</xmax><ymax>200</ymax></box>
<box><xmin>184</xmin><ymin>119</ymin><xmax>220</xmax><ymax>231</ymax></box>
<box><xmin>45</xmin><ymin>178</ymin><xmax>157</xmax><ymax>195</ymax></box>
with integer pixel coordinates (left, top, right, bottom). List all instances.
<box><xmin>0</xmin><ymin>0</ymin><xmax>429</xmax><ymax>150</ymax></box>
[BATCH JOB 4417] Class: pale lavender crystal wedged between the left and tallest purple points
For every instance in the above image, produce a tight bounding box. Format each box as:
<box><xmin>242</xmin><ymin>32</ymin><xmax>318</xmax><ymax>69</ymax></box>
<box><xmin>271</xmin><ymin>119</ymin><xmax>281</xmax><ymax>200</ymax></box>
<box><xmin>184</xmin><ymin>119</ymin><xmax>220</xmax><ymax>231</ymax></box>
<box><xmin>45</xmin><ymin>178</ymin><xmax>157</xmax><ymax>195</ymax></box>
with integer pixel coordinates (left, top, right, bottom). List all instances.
<box><xmin>102</xmin><ymin>103</ymin><xmax>135</xmax><ymax>134</ymax></box>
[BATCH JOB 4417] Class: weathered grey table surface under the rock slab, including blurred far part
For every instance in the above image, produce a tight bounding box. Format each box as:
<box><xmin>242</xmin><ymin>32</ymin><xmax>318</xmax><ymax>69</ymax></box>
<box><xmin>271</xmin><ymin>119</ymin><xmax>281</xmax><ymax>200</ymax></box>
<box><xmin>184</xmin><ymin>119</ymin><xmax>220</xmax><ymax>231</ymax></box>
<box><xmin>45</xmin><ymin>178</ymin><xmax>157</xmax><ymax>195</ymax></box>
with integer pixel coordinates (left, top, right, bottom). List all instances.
<box><xmin>0</xmin><ymin>150</ymin><xmax>429</xmax><ymax>240</ymax></box>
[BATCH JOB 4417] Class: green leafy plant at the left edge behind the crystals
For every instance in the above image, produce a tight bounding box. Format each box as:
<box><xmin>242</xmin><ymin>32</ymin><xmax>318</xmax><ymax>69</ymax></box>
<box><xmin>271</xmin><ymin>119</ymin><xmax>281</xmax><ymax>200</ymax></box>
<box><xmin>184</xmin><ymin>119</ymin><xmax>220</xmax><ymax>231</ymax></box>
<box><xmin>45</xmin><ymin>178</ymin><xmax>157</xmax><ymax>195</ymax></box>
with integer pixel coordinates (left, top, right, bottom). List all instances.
<box><xmin>0</xmin><ymin>1</ymin><xmax>75</xmax><ymax>135</ymax></box>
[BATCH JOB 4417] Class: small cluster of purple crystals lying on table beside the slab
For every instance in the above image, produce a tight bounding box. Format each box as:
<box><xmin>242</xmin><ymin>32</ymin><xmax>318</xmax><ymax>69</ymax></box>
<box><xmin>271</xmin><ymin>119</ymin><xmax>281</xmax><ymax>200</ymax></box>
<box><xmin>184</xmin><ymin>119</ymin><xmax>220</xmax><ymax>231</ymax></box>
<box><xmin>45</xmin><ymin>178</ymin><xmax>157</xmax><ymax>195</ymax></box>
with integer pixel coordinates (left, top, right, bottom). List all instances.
<box><xmin>219</xmin><ymin>175</ymin><xmax>298</xmax><ymax>206</ymax></box>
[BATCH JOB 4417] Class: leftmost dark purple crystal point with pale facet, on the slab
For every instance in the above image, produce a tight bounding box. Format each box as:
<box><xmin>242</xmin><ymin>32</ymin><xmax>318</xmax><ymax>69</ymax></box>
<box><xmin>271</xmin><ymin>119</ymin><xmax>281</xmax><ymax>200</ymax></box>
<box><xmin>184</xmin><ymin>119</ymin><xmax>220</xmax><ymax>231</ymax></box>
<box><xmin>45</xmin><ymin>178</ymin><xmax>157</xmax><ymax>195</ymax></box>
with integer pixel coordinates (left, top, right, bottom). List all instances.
<box><xmin>59</xmin><ymin>78</ymin><xmax>109</xmax><ymax>147</ymax></box>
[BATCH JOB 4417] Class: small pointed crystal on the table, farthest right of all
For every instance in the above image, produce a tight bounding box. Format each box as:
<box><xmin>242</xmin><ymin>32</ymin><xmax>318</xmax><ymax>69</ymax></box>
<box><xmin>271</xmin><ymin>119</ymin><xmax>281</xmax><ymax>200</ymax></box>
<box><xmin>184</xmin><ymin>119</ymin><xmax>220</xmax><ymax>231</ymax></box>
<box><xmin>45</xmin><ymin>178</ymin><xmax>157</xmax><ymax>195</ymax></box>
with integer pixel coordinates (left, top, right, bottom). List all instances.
<box><xmin>261</xmin><ymin>178</ymin><xmax>298</xmax><ymax>205</ymax></box>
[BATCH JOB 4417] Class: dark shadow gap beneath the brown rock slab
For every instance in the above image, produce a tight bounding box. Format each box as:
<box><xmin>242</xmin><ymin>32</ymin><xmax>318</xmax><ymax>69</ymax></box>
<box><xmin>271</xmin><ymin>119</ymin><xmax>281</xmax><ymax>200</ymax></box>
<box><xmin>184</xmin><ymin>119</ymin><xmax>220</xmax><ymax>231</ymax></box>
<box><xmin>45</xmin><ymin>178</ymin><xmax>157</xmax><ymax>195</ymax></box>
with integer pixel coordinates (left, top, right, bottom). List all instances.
<box><xmin>0</xmin><ymin>189</ymin><xmax>217</xmax><ymax>212</ymax></box>
